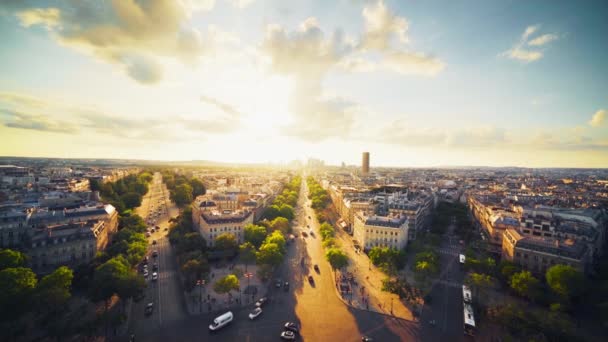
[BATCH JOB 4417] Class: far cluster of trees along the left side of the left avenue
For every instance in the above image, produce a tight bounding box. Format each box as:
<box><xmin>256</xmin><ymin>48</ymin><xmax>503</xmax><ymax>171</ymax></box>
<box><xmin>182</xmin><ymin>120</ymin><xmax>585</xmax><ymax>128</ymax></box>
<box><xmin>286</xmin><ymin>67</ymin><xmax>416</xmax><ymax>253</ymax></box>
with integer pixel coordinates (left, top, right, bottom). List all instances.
<box><xmin>89</xmin><ymin>171</ymin><xmax>152</xmax><ymax>213</ymax></box>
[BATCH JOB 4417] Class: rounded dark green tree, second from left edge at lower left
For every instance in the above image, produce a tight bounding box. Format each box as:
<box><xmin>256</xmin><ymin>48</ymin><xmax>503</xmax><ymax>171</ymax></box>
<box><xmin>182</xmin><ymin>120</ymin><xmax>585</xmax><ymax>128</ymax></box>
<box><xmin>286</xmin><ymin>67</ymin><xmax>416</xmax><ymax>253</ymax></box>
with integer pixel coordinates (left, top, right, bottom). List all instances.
<box><xmin>36</xmin><ymin>266</ymin><xmax>74</xmax><ymax>312</ymax></box>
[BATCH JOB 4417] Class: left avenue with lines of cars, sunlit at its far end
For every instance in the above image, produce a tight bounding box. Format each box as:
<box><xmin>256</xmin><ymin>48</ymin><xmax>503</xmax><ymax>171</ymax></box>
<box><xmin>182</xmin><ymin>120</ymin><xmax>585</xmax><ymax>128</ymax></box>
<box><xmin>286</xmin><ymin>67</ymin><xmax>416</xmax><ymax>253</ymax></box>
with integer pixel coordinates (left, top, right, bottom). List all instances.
<box><xmin>127</xmin><ymin>173</ymin><xmax>187</xmax><ymax>336</ymax></box>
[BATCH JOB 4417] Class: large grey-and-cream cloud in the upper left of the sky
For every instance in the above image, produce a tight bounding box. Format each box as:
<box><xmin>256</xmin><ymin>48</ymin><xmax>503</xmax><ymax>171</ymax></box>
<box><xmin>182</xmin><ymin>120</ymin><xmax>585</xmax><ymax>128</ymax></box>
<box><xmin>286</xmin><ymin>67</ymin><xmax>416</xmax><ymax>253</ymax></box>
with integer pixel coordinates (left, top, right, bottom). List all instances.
<box><xmin>10</xmin><ymin>0</ymin><xmax>214</xmax><ymax>84</ymax></box>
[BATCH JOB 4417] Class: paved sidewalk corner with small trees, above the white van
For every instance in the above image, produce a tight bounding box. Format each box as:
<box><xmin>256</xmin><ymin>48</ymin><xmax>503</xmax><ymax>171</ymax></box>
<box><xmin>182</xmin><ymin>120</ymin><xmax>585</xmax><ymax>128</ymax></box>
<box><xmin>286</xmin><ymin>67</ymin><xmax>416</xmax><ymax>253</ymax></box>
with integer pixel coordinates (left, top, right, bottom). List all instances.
<box><xmin>184</xmin><ymin>264</ymin><xmax>267</xmax><ymax>315</ymax></box>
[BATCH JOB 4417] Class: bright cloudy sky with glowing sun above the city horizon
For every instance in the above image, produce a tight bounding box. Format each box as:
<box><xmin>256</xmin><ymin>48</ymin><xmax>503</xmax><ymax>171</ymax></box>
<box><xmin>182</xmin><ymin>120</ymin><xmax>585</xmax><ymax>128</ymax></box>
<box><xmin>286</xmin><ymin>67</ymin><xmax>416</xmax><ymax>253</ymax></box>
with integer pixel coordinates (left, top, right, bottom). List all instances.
<box><xmin>0</xmin><ymin>0</ymin><xmax>608</xmax><ymax>167</ymax></box>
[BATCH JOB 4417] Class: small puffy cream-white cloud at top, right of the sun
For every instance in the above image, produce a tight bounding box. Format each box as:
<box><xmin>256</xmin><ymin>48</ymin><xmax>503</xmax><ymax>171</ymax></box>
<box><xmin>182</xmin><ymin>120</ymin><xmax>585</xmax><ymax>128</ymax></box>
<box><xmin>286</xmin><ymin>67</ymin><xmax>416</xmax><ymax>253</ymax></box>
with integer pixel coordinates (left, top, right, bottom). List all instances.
<box><xmin>361</xmin><ymin>0</ymin><xmax>409</xmax><ymax>50</ymax></box>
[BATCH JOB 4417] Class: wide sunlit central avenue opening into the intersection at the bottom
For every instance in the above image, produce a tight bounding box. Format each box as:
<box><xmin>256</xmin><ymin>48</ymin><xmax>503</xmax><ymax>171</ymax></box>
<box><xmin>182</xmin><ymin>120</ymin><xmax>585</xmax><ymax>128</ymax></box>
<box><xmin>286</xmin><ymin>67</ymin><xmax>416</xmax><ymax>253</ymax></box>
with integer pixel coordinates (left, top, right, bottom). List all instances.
<box><xmin>120</xmin><ymin>175</ymin><xmax>428</xmax><ymax>342</ymax></box>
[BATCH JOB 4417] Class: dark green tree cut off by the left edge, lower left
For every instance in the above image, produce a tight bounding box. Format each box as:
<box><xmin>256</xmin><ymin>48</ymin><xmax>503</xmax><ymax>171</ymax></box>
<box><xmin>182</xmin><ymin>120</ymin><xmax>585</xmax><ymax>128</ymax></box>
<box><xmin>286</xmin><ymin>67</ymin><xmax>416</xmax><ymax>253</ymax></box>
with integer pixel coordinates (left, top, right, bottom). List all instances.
<box><xmin>0</xmin><ymin>267</ymin><xmax>38</xmax><ymax>320</ymax></box>
